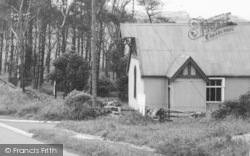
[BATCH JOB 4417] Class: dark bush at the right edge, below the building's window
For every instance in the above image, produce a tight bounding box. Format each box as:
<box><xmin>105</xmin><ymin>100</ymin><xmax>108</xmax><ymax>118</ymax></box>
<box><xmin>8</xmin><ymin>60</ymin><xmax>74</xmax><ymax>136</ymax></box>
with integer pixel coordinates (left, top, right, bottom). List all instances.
<box><xmin>212</xmin><ymin>92</ymin><xmax>250</xmax><ymax>119</ymax></box>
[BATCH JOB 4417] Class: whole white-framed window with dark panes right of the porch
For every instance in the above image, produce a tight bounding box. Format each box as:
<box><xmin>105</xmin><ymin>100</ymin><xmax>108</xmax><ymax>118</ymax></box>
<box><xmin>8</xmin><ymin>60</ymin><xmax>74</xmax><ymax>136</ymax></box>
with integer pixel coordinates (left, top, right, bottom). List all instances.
<box><xmin>206</xmin><ymin>78</ymin><xmax>225</xmax><ymax>103</ymax></box>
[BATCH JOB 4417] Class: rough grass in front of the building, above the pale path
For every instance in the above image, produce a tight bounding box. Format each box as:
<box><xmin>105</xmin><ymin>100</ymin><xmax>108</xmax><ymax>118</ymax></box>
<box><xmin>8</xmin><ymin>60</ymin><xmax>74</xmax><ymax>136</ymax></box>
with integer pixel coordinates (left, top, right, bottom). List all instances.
<box><xmin>58</xmin><ymin>114</ymin><xmax>250</xmax><ymax>156</ymax></box>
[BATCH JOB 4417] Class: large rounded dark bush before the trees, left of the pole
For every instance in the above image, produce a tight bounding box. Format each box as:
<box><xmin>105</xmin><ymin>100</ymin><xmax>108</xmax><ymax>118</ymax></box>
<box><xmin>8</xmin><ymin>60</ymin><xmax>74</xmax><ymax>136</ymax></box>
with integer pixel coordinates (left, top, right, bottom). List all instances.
<box><xmin>48</xmin><ymin>52</ymin><xmax>89</xmax><ymax>94</ymax></box>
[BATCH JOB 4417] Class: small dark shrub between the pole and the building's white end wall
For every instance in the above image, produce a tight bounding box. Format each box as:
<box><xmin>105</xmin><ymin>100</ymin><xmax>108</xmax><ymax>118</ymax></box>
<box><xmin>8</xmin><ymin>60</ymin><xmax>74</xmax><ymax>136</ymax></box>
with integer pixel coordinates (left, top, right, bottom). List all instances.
<box><xmin>98</xmin><ymin>77</ymin><xmax>115</xmax><ymax>97</ymax></box>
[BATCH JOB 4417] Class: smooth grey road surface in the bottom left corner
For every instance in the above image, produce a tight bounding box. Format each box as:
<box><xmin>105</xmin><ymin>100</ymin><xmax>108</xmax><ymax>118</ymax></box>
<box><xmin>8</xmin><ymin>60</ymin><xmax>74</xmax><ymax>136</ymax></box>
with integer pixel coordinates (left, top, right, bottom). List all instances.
<box><xmin>0</xmin><ymin>127</ymin><xmax>77</xmax><ymax>156</ymax></box>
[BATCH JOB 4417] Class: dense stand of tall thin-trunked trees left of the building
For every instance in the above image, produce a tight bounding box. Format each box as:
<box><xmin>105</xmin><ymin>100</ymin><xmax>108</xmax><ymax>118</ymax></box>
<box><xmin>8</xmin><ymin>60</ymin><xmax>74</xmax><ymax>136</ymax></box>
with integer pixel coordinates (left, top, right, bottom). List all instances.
<box><xmin>0</xmin><ymin>0</ymin><xmax>170</xmax><ymax>99</ymax></box>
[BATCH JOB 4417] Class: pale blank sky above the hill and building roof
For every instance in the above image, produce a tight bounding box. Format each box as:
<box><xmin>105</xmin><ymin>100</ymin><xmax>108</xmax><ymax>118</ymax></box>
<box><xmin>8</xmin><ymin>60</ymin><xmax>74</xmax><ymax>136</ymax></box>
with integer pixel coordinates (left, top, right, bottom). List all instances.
<box><xmin>137</xmin><ymin>0</ymin><xmax>250</xmax><ymax>21</ymax></box>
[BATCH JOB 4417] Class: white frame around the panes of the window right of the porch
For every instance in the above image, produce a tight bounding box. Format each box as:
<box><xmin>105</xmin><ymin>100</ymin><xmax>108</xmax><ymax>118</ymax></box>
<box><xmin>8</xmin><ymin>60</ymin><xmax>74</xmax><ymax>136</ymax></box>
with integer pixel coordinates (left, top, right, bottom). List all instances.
<box><xmin>206</xmin><ymin>77</ymin><xmax>225</xmax><ymax>103</ymax></box>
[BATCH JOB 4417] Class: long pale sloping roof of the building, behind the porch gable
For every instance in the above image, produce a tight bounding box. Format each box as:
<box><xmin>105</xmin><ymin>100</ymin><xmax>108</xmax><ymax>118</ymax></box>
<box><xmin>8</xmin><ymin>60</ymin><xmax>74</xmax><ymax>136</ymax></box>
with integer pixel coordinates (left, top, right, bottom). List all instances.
<box><xmin>121</xmin><ymin>23</ymin><xmax>250</xmax><ymax>76</ymax></box>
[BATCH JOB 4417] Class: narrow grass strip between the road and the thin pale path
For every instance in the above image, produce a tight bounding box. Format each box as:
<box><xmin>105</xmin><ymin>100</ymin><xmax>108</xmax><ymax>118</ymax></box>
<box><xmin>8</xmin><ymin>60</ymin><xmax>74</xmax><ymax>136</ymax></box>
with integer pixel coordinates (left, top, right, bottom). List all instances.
<box><xmin>31</xmin><ymin>129</ymin><xmax>158</xmax><ymax>156</ymax></box>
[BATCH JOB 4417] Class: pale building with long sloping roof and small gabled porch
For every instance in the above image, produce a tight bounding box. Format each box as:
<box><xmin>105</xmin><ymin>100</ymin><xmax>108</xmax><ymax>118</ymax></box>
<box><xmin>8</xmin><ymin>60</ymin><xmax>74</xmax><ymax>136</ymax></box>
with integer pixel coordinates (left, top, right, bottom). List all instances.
<box><xmin>121</xmin><ymin>22</ymin><xmax>250</xmax><ymax>111</ymax></box>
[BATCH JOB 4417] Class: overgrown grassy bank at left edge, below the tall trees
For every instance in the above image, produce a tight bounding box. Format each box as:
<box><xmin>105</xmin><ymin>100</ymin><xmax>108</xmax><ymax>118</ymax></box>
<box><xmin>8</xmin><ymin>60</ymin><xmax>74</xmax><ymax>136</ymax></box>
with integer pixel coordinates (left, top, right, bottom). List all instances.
<box><xmin>0</xmin><ymin>85</ymin><xmax>64</xmax><ymax>120</ymax></box>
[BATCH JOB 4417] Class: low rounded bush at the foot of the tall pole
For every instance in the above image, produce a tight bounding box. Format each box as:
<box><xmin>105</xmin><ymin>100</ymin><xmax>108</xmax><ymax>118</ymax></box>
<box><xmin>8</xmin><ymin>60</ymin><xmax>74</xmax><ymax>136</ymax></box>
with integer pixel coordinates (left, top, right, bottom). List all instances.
<box><xmin>64</xmin><ymin>90</ymin><xmax>108</xmax><ymax>120</ymax></box>
